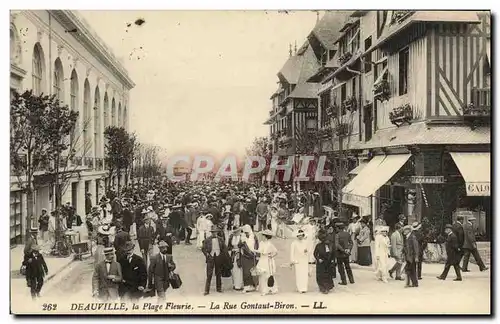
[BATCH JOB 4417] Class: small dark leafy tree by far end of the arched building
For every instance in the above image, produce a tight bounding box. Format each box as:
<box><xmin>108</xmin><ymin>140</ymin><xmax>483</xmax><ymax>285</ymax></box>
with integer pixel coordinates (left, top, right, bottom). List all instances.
<box><xmin>104</xmin><ymin>126</ymin><xmax>136</xmax><ymax>192</ymax></box>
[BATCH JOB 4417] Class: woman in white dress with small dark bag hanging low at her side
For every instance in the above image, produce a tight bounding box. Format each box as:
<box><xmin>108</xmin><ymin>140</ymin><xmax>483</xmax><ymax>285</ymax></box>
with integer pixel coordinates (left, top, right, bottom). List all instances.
<box><xmin>255</xmin><ymin>230</ymin><xmax>278</xmax><ymax>296</ymax></box>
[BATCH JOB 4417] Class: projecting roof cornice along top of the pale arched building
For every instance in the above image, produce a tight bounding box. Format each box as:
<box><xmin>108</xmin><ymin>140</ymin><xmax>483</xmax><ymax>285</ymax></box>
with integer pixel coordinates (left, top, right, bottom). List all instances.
<box><xmin>50</xmin><ymin>10</ymin><xmax>135</xmax><ymax>90</ymax></box>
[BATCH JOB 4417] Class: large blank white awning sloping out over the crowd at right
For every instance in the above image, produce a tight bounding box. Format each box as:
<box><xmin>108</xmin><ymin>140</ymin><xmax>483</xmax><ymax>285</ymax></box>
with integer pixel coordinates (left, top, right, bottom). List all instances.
<box><xmin>342</xmin><ymin>154</ymin><xmax>411</xmax><ymax>197</ymax></box>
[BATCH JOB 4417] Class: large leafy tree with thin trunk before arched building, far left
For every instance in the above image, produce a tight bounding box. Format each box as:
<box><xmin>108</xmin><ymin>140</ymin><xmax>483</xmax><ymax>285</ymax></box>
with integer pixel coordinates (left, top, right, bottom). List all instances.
<box><xmin>10</xmin><ymin>90</ymin><xmax>78</xmax><ymax>239</ymax></box>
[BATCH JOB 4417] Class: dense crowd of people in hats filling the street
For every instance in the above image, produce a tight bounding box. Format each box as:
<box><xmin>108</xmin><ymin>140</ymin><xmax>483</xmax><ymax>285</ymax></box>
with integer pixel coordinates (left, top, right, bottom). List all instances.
<box><xmin>19</xmin><ymin>180</ymin><xmax>487</xmax><ymax>301</ymax></box>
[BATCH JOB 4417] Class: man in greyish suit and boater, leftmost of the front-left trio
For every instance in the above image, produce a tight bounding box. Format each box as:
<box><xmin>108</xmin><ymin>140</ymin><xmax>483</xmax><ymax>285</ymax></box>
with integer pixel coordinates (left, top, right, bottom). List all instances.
<box><xmin>92</xmin><ymin>247</ymin><xmax>123</xmax><ymax>301</ymax></box>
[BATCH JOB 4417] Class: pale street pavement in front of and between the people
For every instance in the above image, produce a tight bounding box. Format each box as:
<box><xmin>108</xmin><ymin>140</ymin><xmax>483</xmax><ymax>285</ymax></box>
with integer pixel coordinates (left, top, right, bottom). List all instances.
<box><xmin>12</xmin><ymin>239</ymin><xmax>490</xmax><ymax>313</ymax></box>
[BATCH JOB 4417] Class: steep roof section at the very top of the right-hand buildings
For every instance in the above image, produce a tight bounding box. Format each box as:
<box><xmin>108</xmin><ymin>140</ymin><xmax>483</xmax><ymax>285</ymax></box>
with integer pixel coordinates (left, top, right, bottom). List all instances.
<box><xmin>311</xmin><ymin>10</ymin><xmax>354</xmax><ymax>50</ymax></box>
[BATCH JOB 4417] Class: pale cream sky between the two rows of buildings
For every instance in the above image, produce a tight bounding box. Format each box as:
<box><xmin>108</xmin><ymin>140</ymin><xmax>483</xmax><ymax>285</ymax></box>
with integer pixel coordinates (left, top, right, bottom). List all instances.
<box><xmin>80</xmin><ymin>11</ymin><xmax>317</xmax><ymax>157</ymax></box>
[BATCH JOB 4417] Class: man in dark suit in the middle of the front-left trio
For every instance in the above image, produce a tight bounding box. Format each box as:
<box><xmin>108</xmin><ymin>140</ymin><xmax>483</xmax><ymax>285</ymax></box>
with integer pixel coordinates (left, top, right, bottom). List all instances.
<box><xmin>119</xmin><ymin>241</ymin><xmax>148</xmax><ymax>301</ymax></box>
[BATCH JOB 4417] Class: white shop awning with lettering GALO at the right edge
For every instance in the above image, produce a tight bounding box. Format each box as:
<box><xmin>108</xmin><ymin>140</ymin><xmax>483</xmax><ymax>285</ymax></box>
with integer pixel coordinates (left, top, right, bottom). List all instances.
<box><xmin>450</xmin><ymin>152</ymin><xmax>491</xmax><ymax>196</ymax></box>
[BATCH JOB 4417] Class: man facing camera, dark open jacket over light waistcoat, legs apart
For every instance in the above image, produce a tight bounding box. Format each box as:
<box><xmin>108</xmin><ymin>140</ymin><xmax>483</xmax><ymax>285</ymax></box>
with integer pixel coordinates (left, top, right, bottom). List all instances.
<box><xmin>201</xmin><ymin>225</ymin><xmax>226</xmax><ymax>295</ymax></box>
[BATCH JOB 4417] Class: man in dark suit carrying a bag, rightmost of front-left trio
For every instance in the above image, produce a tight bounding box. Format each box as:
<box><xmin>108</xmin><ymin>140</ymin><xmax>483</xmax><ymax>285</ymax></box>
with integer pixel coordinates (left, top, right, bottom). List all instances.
<box><xmin>149</xmin><ymin>241</ymin><xmax>175</xmax><ymax>303</ymax></box>
